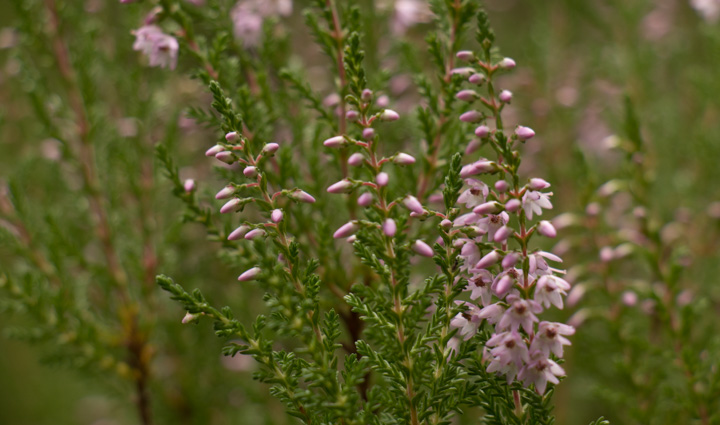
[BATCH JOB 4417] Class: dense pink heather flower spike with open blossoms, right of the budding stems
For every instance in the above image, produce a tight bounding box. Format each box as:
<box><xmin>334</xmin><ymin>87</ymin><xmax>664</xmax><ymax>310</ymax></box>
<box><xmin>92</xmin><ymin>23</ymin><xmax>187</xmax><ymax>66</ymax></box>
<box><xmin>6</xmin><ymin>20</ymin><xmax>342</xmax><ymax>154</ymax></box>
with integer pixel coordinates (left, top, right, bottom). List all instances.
<box><xmin>446</xmin><ymin>46</ymin><xmax>575</xmax><ymax>394</ymax></box>
